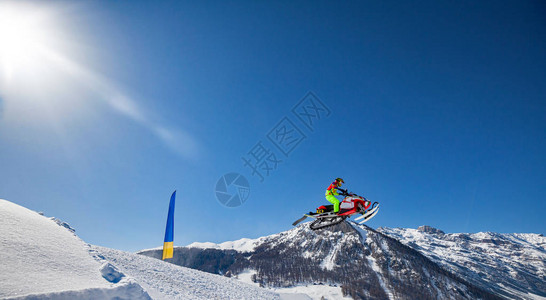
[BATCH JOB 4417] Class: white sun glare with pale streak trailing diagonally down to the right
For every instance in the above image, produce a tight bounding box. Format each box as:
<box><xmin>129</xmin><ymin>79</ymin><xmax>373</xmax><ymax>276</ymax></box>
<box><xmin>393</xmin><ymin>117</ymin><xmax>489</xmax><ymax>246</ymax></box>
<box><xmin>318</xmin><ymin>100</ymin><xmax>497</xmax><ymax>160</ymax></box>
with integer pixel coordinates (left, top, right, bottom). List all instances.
<box><xmin>0</xmin><ymin>0</ymin><xmax>197</xmax><ymax>157</ymax></box>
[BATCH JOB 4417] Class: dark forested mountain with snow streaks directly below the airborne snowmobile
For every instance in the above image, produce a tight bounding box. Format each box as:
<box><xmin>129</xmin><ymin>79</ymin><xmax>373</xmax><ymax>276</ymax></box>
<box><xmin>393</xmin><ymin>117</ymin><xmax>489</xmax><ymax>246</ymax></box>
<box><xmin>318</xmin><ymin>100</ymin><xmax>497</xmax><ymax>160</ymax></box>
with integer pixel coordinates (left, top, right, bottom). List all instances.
<box><xmin>138</xmin><ymin>223</ymin><xmax>544</xmax><ymax>299</ymax></box>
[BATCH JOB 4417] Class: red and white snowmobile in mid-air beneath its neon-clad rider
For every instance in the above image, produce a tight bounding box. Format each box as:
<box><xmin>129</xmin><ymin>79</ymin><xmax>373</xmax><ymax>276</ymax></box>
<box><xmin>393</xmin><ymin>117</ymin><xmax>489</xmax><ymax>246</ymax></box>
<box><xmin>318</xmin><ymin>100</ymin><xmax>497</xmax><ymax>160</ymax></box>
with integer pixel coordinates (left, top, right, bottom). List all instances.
<box><xmin>292</xmin><ymin>189</ymin><xmax>379</xmax><ymax>230</ymax></box>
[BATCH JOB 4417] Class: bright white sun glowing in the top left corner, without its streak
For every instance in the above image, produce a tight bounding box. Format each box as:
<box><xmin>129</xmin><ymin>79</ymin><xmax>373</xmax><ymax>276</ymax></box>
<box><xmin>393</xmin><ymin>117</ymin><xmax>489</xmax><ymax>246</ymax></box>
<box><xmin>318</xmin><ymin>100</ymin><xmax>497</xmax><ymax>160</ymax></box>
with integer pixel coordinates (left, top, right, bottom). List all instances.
<box><xmin>0</xmin><ymin>0</ymin><xmax>83</xmax><ymax>120</ymax></box>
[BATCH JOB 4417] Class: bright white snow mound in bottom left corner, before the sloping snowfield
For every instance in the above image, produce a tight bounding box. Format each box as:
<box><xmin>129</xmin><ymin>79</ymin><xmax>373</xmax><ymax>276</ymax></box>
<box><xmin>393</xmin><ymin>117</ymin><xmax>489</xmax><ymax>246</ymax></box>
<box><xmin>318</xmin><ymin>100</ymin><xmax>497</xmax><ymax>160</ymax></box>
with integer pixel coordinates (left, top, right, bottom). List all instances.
<box><xmin>0</xmin><ymin>200</ymin><xmax>150</xmax><ymax>299</ymax></box>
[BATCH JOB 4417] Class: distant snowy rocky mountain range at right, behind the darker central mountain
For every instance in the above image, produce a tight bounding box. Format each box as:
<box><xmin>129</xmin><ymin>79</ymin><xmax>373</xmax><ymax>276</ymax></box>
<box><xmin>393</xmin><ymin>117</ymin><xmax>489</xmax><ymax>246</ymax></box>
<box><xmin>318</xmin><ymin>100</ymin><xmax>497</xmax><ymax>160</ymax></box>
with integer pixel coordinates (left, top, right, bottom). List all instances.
<box><xmin>378</xmin><ymin>226</ymin><xmax>546</xmax><ymax>299</ymax></box>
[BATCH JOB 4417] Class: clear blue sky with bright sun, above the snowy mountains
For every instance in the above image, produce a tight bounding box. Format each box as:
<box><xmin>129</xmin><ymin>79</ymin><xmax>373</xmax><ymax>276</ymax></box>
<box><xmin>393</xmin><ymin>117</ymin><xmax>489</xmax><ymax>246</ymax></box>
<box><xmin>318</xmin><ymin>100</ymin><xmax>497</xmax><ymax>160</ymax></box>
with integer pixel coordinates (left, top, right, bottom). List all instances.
<box><xmin>0</xmin><ymin>1</ymin><xmax>546</xmax><ymax>251</ymax></box>
